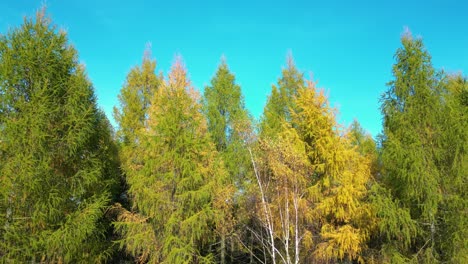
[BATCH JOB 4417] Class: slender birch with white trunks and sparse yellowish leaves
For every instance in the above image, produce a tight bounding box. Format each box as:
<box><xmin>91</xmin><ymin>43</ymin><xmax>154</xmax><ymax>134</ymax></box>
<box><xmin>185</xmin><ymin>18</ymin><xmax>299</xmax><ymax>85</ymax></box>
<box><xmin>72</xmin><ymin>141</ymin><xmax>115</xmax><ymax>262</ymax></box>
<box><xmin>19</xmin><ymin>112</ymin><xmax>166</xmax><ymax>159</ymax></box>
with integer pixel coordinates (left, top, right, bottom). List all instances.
<box><xmin>251</xmin><ymin>122</ymin><xmax>312</xmax><ymax>264</ymax></box>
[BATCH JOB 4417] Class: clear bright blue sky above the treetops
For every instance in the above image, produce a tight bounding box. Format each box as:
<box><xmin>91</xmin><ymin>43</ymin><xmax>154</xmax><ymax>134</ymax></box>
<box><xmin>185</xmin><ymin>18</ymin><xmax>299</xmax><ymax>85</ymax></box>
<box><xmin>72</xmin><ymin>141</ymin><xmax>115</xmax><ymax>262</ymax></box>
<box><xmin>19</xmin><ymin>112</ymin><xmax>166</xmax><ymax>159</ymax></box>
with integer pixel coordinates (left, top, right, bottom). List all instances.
<box><xmin>0</xmin><ymin>0</ymin><xmax>468</xmax><ymax>136</ymax></box>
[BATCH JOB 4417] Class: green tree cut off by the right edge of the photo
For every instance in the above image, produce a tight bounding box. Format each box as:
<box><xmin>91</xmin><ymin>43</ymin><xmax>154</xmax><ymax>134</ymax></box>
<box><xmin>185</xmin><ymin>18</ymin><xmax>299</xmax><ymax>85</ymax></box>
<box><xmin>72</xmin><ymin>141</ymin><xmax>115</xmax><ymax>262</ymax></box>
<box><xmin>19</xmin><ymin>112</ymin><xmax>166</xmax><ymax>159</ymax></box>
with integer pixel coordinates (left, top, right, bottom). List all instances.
<box><xmin>435</xmin><ymin>74</ymin><xmax>468</xmax><ymax>263</ymax></box>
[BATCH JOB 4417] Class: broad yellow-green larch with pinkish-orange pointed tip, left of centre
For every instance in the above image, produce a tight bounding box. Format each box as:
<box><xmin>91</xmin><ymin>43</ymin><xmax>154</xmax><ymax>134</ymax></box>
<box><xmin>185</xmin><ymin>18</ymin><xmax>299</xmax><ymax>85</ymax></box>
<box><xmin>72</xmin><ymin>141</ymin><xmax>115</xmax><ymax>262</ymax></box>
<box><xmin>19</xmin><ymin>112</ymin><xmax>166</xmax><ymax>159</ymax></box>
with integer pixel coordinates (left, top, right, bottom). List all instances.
<box><xmin>115</xmin><ymin>56</ymin><xmax>230</xmax><ymax>263</ymax></box>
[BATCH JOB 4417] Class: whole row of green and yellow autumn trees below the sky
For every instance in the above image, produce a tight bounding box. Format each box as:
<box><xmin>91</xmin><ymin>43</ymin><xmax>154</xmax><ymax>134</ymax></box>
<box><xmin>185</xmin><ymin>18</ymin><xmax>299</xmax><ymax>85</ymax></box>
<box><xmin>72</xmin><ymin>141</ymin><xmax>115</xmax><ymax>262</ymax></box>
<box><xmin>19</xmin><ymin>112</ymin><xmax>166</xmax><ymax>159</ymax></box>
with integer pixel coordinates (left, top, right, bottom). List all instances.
<box><xmin>0</xmin><ymin>11</ymin><xmax>468</xmax><ymax>264</ymax></box>
